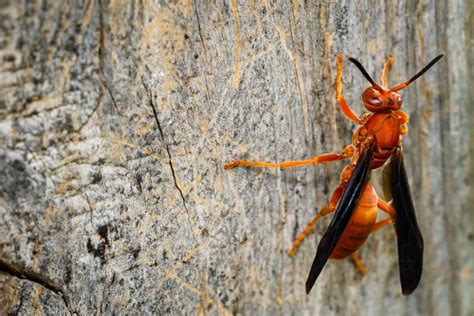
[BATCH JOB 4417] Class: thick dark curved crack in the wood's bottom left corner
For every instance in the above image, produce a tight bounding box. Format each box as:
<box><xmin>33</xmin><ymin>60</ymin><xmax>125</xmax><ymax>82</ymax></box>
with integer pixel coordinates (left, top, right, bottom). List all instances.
<box><xmin>0</xmin><ymin>258</ymin><xmax>77</xmax><ymax>315</ymax></box>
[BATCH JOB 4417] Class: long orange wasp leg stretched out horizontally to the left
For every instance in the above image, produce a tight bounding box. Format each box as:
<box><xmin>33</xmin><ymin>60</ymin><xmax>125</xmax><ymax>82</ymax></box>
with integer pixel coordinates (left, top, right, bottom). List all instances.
<box><xmin>224</xmin><ymin>145</ymin><xmax>354</xmax><ymax>169</ymax></box>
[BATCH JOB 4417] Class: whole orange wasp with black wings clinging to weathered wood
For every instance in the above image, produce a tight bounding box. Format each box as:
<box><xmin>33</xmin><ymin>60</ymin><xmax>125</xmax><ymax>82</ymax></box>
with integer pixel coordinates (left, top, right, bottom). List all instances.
<box><xmin>224</xmin><ymin>55</ymin><xmax>444</xmax><ymax>295</ymax></box>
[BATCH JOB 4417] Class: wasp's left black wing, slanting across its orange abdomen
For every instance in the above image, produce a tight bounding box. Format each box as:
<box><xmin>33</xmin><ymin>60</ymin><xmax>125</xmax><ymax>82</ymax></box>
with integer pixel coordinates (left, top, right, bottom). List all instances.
<box><xmin>306</xmin><ymin>144</ymin><xmax>374</xmax><ymax>294</ymax></box>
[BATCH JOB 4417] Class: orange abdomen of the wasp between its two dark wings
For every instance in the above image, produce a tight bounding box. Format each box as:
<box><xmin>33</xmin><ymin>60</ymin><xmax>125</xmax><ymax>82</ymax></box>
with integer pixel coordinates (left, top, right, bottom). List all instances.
<box><xmin>330</xmin><ymin>184</ymin><xmax>378</xmax><ymax>259</ymax></box>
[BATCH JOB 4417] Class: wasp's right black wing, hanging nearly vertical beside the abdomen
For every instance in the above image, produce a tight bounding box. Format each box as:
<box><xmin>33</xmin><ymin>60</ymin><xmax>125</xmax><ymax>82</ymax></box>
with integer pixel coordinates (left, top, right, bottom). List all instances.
<box><xmin>391</xmin><ymin>147</ymin><xmax>423</xmax><ymax>295</ymax></box>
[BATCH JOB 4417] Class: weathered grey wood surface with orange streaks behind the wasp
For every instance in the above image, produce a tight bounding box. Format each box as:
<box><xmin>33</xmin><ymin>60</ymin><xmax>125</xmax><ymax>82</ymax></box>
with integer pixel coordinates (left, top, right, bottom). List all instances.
<box><xmin>0</xmin><ymin>0</ymin><xmax>474</xmax><ymax>315</ymax></box>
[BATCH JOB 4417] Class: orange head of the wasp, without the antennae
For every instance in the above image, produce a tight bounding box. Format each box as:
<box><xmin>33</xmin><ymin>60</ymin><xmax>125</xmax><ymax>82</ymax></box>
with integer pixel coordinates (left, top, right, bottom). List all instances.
<box><xmin>362</xmin><ymin>87</ymin><xmax>402</xmax><ymax>112</ymax></box>
